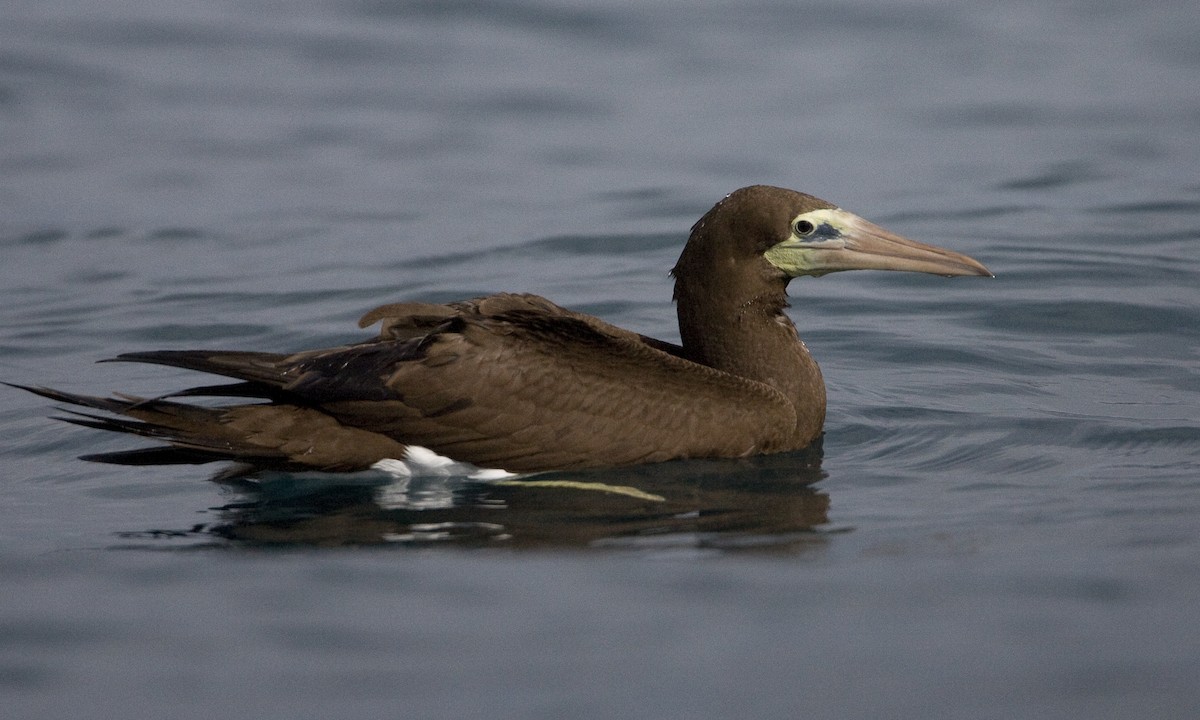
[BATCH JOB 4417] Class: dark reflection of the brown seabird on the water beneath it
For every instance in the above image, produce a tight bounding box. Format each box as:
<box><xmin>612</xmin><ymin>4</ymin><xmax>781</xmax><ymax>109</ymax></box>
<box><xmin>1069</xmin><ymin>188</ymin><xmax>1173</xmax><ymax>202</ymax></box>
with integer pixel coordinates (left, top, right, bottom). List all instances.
<box><xmin>204</xmin><ymin>453</ymin><xmax>829</xmax><ymax>552</ymax></box>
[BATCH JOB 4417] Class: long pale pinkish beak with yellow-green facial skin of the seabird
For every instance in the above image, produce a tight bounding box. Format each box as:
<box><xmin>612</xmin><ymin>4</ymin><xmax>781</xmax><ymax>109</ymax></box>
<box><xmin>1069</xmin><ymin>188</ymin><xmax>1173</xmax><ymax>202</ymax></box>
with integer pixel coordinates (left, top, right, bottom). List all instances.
<box><xmin>766</xmin><ymin>209</ymin><xmax>992</xmax><ymax>277</ymax></box>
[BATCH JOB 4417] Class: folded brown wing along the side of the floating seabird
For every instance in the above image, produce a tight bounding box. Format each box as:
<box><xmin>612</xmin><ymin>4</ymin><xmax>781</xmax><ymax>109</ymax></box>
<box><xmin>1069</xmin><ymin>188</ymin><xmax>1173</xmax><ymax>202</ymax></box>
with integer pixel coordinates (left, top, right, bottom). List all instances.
<box><xmin>91</xmin><ymin>295</ymin><xmax>796</xmax><ymax>472</ymax></box>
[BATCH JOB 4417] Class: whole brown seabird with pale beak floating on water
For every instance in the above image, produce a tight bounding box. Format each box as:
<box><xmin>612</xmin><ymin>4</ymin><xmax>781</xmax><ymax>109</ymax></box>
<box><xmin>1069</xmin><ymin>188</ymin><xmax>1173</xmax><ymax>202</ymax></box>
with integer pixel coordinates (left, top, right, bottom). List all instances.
<box><xmin>11</xmin><ymin>186</ymin><xmax>990</xmax><ymax>473</ymax></box>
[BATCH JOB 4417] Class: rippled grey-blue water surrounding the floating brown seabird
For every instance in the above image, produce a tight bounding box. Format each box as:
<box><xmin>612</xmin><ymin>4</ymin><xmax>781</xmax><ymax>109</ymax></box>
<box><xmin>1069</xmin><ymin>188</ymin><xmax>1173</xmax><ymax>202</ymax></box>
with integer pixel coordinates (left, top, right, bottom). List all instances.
<box><xmin>0</xmin><ymin>0</ymin><xmax>1200</xmax><ymax>719</ymax></box>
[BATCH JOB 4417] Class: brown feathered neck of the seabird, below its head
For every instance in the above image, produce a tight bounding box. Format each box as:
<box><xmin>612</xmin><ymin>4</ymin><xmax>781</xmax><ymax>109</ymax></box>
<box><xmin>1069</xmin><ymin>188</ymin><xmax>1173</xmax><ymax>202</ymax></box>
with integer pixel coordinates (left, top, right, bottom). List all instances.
<box><xmin>676</xmin><ymin>282</ymin><xmax>826</xmax><ymax>438</ymax></box>
